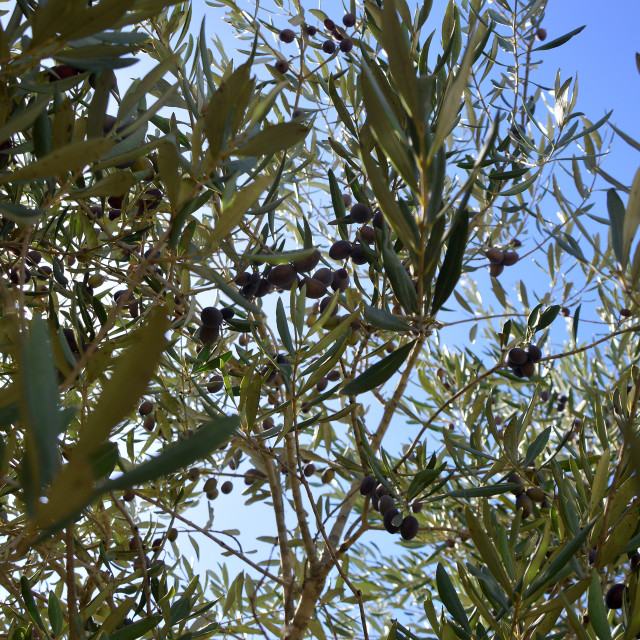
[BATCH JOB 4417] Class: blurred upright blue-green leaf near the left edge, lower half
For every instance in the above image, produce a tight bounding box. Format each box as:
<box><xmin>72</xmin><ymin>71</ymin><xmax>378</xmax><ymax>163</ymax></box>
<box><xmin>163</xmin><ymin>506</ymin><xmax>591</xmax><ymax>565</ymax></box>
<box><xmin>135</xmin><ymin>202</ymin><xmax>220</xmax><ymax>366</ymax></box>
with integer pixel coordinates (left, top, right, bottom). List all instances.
<box><xmin>19</xmin><ymin>317</ymin><xmax>61</xmax><ymax>487</ymax></box>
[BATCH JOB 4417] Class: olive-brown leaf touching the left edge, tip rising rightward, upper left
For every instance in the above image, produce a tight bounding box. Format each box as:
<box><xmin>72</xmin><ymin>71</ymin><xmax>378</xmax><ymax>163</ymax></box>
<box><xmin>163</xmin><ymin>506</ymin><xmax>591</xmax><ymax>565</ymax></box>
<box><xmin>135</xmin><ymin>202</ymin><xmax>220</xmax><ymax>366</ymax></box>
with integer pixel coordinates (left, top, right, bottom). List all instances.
<box><xmin>0</xmin><ymin>138</ymin><xmax>115</xmax><ymax>184</ymax></box>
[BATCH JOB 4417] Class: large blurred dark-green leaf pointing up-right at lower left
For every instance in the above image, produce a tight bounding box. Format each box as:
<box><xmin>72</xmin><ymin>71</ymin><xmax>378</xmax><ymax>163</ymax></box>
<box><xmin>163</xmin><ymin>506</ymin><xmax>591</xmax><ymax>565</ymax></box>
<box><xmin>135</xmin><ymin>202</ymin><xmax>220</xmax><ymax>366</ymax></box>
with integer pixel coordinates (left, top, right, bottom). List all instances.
<box><xmin>105</xmin><ymin>416</ymin><xmax>240</xmax><ymax>491</ymax></box>
